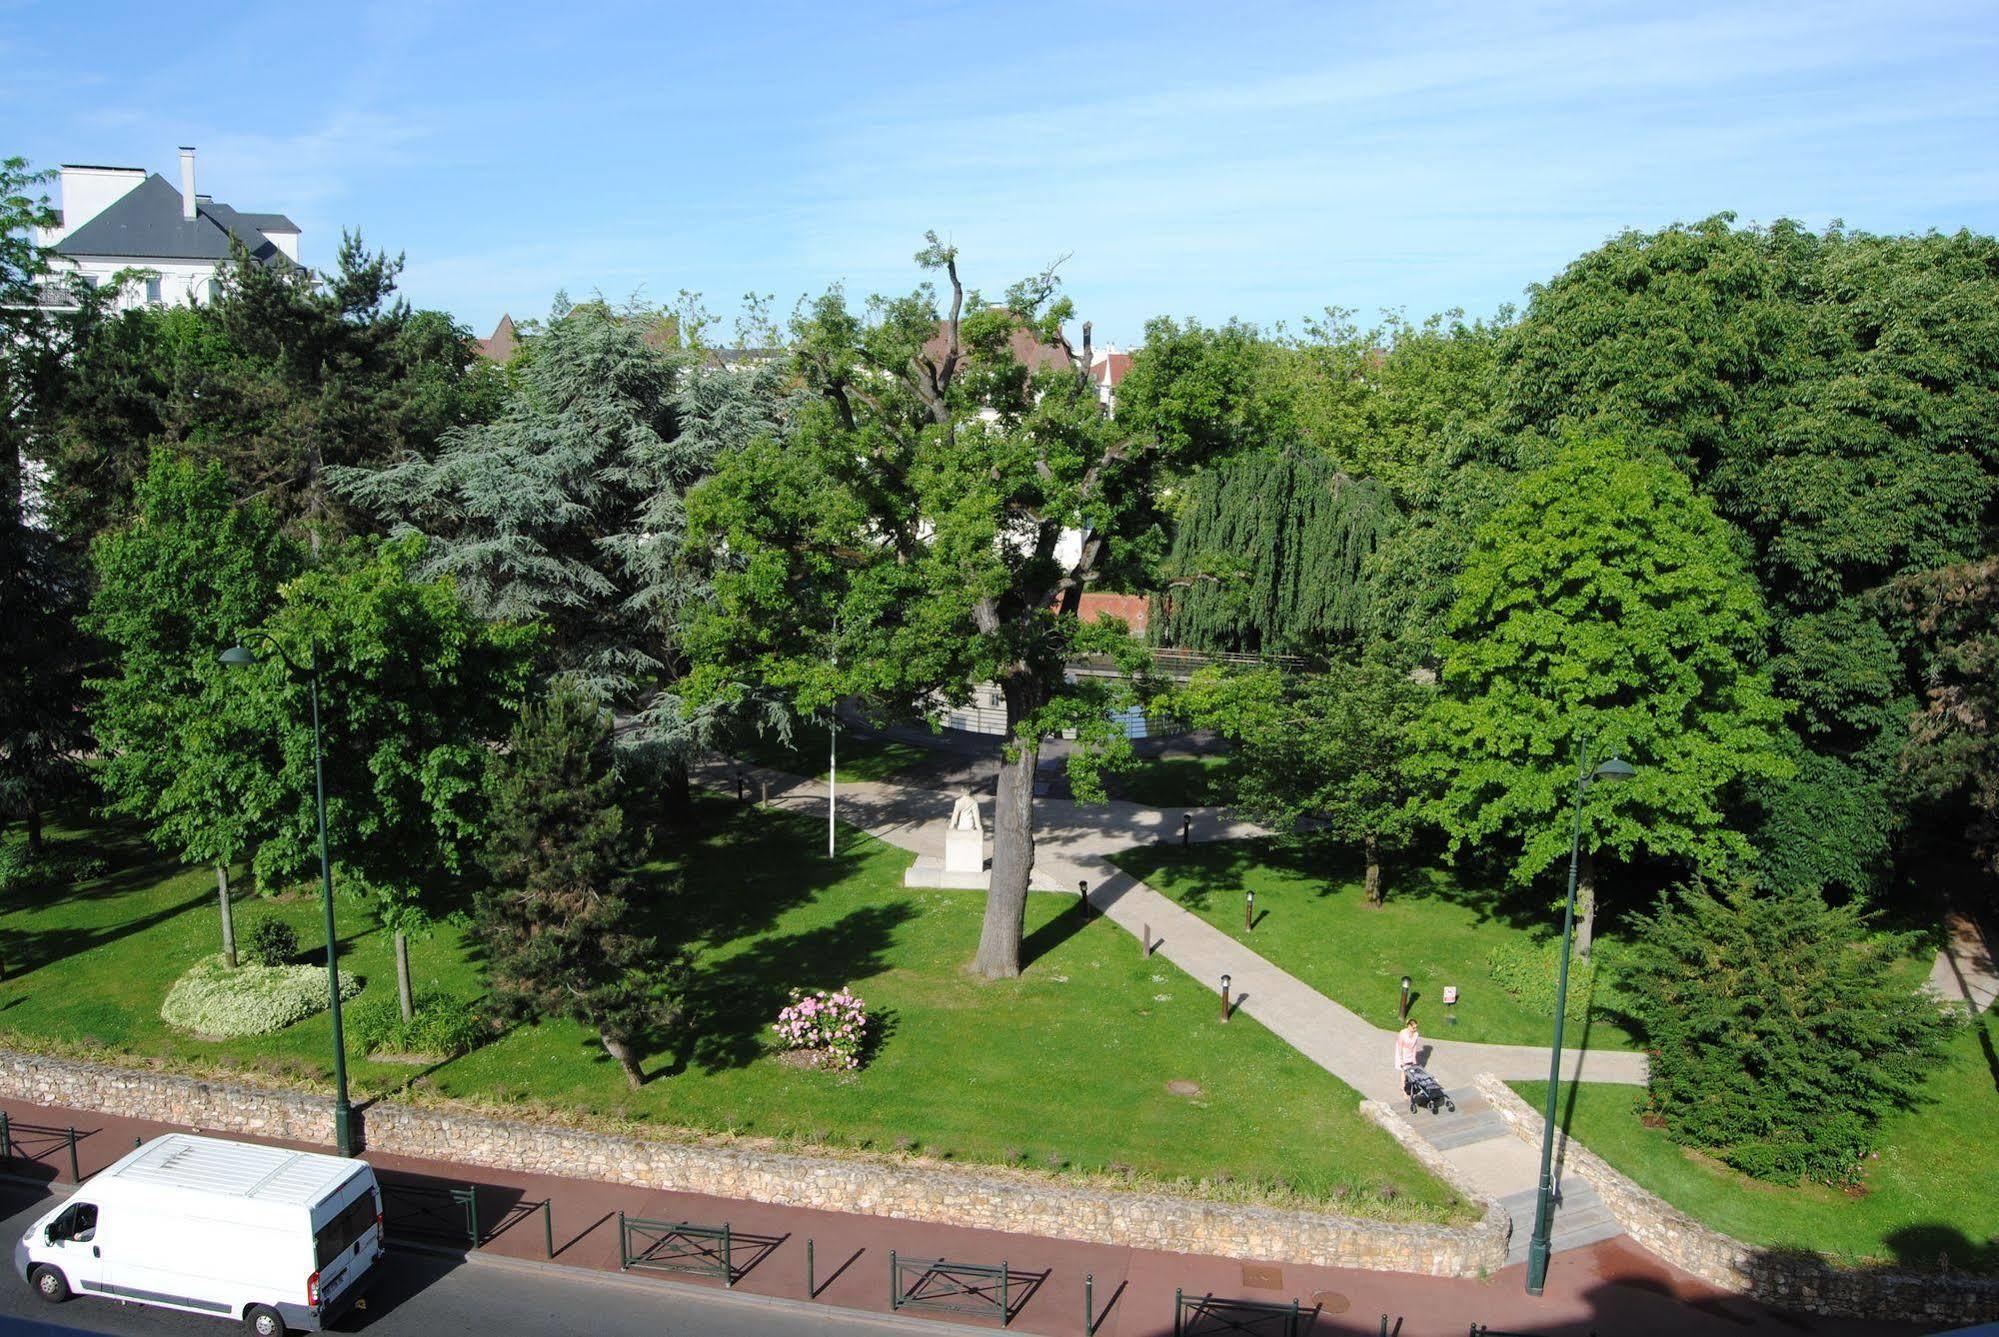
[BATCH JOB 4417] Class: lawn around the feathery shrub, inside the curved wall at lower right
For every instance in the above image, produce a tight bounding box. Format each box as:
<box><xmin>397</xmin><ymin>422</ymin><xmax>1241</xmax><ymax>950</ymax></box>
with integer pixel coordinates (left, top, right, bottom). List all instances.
<box><xmin>1515</xmin><ymin>1019</ymin><xmax>1999</xmax><ymax>1273</ymax></box>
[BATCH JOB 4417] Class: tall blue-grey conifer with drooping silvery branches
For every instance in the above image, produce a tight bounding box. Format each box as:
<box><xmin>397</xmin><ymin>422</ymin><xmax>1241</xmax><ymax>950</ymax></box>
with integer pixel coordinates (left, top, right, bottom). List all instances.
<box><xmin>336</xmin><ymin>304</ymin><xmax>712</xmax><ymax>787</ymax></box>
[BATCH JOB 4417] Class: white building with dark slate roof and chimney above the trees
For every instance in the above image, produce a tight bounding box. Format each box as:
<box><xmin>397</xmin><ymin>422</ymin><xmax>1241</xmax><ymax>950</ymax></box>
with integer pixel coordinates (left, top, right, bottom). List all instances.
<box><xmin>34</xmin><ymin>148</ymin><xmax>298</xmax><ymax>306</ymax></box>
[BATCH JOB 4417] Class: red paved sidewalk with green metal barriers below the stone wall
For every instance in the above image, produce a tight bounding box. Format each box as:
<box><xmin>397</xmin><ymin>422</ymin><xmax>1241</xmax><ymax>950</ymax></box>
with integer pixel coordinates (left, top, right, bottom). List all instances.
<box><xmin>0</xmin><ymin>1101</ymin><xmax>1921</xmax><ymax>1337</ymax></box>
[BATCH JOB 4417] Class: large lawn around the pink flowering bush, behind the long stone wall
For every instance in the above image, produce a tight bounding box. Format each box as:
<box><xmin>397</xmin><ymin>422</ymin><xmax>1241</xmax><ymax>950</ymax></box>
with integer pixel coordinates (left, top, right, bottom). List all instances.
<box><xmin>0</xmin><ymin>799</ymin><xmax>1465</xmax><ymax>1219</ymax></box>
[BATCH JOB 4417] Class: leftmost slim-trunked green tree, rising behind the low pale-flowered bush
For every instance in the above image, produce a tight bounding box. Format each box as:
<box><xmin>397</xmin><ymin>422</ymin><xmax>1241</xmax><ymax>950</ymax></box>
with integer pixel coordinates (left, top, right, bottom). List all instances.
<box><xmin>90</xmin><ymin>450</ymin><xmax>302</xmax><ymax>965</ymax></box>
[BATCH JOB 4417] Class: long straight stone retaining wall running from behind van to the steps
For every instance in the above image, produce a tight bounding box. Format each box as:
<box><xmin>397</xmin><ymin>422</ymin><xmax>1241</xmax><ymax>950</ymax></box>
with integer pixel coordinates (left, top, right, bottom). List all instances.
<box><xmin>0</xmin><ymin>1051</ymin><xmax>1507</xmax><ymax>1277</ymax></box>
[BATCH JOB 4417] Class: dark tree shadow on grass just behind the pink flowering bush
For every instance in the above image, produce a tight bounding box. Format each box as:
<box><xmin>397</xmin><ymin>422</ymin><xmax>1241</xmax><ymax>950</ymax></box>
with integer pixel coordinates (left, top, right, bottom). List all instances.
<box><xmin>668</xmin><ymin>903</ymin><xmax>916</xmax><ymax>1073</ymax></box>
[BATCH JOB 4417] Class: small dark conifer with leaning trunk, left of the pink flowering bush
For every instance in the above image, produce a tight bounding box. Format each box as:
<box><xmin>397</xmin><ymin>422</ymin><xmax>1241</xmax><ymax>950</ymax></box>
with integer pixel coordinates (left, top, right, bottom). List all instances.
<box><xmin>476</xmin><ymin>683</ymin><xmax>680</xmax><ymax>1089</ymax></box>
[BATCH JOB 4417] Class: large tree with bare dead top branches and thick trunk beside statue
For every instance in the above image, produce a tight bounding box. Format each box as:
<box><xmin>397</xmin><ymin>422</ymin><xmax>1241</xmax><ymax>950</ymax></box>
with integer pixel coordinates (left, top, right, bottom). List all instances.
<box><xmin>690</xmin><ymin>236</ymin><xmax>1171</xmax><ymax>977</ymax></box>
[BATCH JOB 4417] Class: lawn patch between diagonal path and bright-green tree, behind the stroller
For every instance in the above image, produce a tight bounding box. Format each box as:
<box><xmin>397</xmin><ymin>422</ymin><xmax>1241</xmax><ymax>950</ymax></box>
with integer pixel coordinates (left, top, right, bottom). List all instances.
<box><xmin>1115</xmin><ymin>841</ymin><xmax>1633</xmax><ymax>1049</ymax></box>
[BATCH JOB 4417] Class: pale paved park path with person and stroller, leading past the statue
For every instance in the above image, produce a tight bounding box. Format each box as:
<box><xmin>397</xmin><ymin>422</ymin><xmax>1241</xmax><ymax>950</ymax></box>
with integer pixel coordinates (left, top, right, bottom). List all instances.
<box><xmin>696</xmin><ymin>759</ymin><xmax>1645</xmax><ymax>1261</ymax></box>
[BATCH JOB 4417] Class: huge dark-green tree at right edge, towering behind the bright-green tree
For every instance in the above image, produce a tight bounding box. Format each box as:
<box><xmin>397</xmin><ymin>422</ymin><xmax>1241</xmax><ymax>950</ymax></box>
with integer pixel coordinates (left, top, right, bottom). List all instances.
<box><xmin>1499</xmin><ymin>214</ymin><xmax>1999</xmax><ymax>889</ymax></box>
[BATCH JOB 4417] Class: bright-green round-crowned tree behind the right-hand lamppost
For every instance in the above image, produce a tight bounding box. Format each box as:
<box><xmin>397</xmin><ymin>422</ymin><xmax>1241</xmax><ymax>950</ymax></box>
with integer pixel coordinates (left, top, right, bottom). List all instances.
<box><xmin>1419</xmin><ymin>438</ymin><xmax>1789</xmax><ymax>953</ymax></box>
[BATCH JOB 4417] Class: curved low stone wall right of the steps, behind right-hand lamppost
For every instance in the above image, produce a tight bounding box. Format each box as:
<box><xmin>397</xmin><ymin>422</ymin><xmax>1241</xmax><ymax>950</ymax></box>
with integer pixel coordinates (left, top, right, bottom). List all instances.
<box><xmin>1477</xmin><ymin>1073</ymin><xmax>1999</xmax><ymax>1325</ymax></box>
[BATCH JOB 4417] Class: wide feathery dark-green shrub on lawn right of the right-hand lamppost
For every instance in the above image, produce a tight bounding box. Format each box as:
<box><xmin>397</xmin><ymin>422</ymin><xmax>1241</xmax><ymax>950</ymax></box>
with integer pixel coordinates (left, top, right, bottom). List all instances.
<box><xmin>1625</xmin><ymin>887</ymin><xmax>1951</xmax><ymax>1183</ymax></box>
